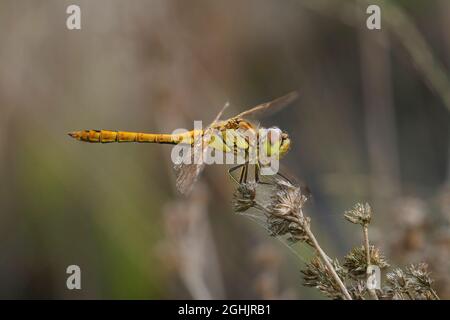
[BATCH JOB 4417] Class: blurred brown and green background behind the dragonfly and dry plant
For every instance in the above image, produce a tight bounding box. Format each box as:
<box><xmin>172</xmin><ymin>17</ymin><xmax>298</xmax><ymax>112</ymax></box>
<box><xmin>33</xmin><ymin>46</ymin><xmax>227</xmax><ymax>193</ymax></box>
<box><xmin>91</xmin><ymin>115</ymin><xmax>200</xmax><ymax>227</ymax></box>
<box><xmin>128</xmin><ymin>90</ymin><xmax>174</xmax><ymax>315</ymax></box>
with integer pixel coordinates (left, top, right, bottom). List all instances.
<box><xmin>0</xmin><ymin>0</ymin><xmax>450</xmax><ymax>299</ymax></box>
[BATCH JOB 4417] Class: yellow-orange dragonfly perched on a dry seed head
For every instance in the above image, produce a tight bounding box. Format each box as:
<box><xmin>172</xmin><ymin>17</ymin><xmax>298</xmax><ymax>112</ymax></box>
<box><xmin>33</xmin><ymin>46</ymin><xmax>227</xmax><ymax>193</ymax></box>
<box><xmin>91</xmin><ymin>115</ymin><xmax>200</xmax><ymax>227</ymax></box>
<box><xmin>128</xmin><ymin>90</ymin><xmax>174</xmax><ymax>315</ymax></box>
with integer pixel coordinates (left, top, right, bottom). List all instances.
<box><xmin>68</xmin><ymin>91</ymin><xmax>298</xmax><ymax>195</ymax></box>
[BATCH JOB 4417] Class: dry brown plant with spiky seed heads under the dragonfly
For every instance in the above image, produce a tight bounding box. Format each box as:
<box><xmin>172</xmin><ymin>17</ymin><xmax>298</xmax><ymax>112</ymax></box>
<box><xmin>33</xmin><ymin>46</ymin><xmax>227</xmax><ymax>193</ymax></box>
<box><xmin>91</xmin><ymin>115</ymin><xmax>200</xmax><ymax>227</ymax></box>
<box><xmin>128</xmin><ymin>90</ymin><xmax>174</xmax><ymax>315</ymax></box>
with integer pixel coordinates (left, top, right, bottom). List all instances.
<box><xmin>233</xmin><ymin>179</ymin><xmax>439</xmax><ymax>300</ymax></box>
